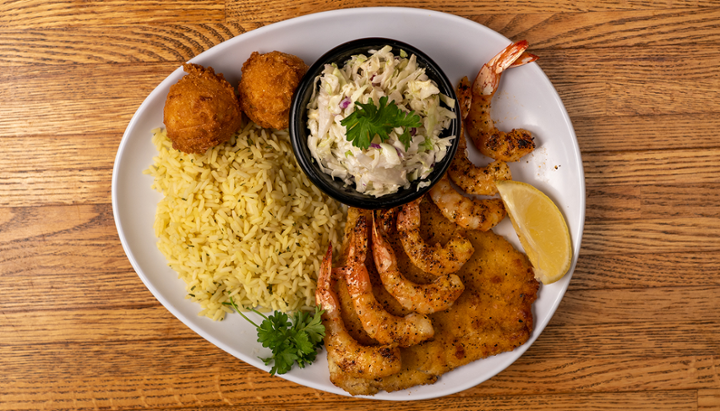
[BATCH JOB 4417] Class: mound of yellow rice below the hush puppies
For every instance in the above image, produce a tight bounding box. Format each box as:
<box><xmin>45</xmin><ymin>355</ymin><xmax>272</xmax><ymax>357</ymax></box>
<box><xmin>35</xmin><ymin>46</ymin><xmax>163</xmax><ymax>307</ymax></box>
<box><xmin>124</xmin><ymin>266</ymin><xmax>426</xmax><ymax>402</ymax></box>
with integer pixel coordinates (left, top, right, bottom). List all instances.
<box><xmin>145</xmin><ymin>123</ymin><xmax>345</xmax><ymax>320</ymax></box>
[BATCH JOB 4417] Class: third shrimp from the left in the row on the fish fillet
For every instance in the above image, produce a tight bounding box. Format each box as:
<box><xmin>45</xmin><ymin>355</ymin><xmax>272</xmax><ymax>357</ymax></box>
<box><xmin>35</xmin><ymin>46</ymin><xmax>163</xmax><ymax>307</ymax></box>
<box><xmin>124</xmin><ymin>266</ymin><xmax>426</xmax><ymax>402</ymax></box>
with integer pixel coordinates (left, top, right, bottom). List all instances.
<box><xmin>372</xmin><ymin>212</ymin><xmax>465</xmax><ymax>314</ymax></box>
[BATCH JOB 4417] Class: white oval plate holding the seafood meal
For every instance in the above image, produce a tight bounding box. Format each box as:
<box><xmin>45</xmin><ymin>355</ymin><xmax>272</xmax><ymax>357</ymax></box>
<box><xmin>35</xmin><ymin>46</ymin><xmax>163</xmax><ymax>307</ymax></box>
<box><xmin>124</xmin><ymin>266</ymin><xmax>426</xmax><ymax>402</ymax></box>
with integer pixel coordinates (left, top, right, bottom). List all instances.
<box><xmin>112</xmin><ymin>8</ymin><xmax>585</xmax><ymax>400</ymax></box>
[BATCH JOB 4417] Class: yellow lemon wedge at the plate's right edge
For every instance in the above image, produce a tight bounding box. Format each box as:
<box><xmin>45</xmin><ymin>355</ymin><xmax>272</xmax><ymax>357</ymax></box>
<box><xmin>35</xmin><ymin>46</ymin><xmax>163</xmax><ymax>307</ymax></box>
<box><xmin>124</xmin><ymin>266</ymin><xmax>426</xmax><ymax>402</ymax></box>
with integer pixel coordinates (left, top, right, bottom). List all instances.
<box><xmin>497</xmin><ymin>180</ymin><xmax>572</xmax><ymax>284</ymax></box>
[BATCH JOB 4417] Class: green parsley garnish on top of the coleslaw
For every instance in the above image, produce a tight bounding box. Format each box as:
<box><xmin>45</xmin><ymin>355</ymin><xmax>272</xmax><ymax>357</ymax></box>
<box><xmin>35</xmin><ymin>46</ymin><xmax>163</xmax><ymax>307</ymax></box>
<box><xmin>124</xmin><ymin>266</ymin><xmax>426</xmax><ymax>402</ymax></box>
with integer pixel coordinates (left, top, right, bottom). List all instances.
<box><xmin>340</xmin><ymin>96</ymin><xmax>422</xmax><ymax>150</ymax></box>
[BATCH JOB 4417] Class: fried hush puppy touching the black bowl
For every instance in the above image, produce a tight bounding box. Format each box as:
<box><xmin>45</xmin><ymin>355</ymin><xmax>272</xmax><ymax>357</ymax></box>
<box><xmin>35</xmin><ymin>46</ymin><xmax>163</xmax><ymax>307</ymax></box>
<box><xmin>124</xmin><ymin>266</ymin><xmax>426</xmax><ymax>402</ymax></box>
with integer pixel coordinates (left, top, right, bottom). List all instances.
<box><xmin>238</xmin><ymin>51</ymin><xmax>308</xmax><ymax>130</ymax></box>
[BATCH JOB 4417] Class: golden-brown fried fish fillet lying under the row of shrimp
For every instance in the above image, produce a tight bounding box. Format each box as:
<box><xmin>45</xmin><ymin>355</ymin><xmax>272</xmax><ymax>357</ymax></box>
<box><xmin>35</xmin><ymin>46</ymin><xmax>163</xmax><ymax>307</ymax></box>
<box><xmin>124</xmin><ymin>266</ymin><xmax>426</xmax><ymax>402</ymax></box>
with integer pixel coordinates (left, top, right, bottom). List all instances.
<box><xmin>330</xmin><ymin>199</ymin><xmax>539</xmax><ymax>395</ymax></box>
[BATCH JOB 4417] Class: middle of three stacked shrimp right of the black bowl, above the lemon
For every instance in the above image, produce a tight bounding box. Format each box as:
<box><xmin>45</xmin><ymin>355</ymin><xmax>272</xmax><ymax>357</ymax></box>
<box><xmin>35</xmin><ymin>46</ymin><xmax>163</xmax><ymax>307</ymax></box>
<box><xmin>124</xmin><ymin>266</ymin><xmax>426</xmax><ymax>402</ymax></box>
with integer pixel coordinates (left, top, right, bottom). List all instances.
<box><xmin>447</xmin><ymin>77</ymin><xmax>512</xmax><ymax>195</ymax></box>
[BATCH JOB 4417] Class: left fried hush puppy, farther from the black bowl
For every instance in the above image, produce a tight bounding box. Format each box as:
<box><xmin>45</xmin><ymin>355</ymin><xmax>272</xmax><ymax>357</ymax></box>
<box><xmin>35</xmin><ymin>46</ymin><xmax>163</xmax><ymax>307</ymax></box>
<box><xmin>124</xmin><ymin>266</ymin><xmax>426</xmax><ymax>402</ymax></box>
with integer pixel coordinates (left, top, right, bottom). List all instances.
<box><xmin>163</xmin><ymin>63</ymin><xmax>242</xmax><ymax>154</ymax></box>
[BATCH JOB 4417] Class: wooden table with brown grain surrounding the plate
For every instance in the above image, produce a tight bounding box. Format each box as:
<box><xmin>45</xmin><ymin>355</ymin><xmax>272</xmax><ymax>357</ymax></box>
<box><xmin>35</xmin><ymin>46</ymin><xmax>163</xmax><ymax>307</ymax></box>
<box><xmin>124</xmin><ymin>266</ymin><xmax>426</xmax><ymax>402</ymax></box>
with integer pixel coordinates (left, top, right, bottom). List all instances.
<box><xmin>0</xmin><ymin>0</ymin><xmax>720</xmax><ymax>410</ymax></box>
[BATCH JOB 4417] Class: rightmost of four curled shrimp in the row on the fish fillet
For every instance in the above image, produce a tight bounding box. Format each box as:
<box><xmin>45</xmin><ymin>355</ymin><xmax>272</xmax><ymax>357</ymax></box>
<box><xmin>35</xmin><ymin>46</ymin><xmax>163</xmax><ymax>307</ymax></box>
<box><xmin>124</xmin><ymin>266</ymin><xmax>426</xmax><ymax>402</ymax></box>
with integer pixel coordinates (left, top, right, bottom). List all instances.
<box><xmin>397</xmin><ymin>197</ymin><xmax>475</xmax><ymax>275</ymax></box>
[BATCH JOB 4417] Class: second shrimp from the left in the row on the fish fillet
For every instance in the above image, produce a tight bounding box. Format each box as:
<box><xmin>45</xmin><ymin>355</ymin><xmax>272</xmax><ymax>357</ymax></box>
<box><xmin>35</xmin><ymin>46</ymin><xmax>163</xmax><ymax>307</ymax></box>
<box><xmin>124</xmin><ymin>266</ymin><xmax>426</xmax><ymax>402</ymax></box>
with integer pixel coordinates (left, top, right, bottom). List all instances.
<box><xmin>337</xmin><ymin>216</ymin><xmax>435</xmax><ymax>347</ymax></box>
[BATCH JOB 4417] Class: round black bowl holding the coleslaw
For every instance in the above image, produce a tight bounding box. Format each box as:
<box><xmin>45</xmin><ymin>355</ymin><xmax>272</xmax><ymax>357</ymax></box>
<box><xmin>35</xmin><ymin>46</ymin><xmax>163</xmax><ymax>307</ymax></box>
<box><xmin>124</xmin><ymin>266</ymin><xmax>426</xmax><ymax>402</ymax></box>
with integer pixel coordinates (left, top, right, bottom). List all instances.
<box><xmin>290</xmin><ymin>38</ymin><xmax>460</xmax><ymax>209</ymax></box>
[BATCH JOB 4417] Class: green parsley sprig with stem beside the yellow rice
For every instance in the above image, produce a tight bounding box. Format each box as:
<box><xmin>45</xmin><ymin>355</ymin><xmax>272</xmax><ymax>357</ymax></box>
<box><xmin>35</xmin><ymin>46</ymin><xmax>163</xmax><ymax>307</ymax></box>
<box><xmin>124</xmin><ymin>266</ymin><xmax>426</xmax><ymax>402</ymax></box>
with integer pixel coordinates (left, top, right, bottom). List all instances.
<box><xmin>223</xmin><ymin>297</ymin><xmax>325</xmax><ymax>375</ymax></box>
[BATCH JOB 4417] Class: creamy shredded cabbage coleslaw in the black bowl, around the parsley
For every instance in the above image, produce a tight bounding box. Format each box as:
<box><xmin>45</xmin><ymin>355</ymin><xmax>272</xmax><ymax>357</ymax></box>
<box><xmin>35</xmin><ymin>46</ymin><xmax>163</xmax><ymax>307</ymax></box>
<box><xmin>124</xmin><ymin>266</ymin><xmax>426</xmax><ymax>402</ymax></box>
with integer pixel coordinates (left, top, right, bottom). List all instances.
<box><xmin>307</xmin><ymin>46</ymin><xmax>455</xmax><ymax>197</ymax></box>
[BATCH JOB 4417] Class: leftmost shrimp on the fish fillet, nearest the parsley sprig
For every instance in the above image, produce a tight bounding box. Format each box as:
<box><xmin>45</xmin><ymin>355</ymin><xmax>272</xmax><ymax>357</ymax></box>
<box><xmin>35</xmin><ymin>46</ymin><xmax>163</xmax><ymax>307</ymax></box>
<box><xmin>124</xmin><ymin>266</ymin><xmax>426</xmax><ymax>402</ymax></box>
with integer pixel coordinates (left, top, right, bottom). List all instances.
<box><xmin>315</xmin><ymin>245</ymin><xmax>402</xmax><ymax>378</ymax></box>
